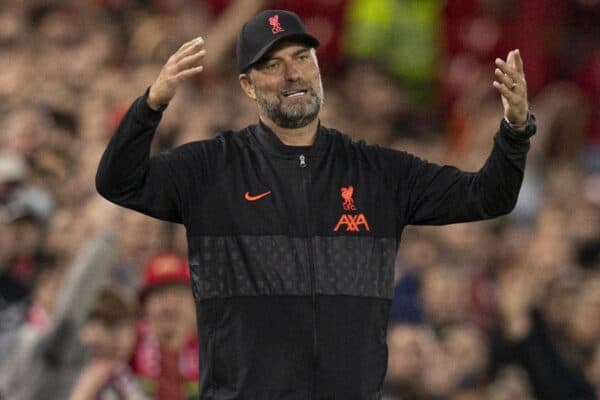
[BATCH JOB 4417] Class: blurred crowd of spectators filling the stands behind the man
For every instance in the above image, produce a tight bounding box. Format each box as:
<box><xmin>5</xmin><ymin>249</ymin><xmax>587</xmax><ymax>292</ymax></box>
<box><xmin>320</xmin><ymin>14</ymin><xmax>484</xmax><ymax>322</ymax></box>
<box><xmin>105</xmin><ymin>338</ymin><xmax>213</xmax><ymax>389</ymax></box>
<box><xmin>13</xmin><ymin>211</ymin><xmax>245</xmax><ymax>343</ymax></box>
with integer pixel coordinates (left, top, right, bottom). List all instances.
<box><xmin>0</xmin><ymin>0</ymin><xmax>600</xmax><ymax>400</ymax></box>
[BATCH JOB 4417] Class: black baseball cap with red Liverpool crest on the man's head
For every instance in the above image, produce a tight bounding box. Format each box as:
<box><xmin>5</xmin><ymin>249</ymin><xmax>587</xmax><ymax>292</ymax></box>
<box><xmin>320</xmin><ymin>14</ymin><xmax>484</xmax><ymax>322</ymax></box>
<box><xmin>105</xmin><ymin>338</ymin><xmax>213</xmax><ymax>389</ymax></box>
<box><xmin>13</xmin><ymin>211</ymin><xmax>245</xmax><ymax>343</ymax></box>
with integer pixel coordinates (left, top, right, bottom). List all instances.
<box><xmin>236</xmin><ymin>10</ymin><xmax>319</xmax><ymax>72</ymax></box>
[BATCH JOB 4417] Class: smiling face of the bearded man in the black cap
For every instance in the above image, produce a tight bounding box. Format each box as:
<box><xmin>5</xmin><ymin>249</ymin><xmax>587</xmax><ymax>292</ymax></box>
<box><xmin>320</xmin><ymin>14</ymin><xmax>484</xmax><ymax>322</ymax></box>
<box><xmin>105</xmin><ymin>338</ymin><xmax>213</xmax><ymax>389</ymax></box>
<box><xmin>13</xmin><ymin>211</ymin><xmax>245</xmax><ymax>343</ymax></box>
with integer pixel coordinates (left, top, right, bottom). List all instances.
<box><xmin>240</xmin><ymin>43</ymin><xmax>323</xmax><ymax>129</ymax></box>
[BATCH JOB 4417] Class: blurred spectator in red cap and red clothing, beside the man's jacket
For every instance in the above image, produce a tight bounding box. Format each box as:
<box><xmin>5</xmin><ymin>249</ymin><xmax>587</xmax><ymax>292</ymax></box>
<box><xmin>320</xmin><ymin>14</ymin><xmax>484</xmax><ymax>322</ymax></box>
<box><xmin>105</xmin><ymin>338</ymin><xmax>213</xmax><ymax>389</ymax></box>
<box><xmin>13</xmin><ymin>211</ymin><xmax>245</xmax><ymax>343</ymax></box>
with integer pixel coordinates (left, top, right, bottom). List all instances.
<box><xmin>132</xmin><ymin>252</ymin><xmax>200</xmax><ymax>400</ymax></box>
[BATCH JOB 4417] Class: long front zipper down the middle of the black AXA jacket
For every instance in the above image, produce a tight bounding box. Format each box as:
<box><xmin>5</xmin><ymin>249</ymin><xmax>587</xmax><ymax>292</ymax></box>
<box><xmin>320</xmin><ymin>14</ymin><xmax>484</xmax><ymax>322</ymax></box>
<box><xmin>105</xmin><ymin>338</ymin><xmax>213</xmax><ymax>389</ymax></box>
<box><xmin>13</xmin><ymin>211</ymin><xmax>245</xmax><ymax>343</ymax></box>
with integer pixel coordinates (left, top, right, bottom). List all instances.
<box><xmin>298</xmin><ymin>154</ymin><xmax>319</xmax><ymax>398</ymax></box>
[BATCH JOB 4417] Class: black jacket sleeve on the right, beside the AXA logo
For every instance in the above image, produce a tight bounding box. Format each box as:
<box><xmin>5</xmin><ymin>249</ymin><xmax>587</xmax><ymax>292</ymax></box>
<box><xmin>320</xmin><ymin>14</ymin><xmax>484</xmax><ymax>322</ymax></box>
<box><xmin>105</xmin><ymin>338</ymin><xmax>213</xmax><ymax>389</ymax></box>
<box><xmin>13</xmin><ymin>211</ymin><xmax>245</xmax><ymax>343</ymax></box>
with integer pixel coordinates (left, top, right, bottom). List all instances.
<box><xmin>394</xmin><ymin>114</ymin><xmax>536</xmax><ymax>225</ymax></box>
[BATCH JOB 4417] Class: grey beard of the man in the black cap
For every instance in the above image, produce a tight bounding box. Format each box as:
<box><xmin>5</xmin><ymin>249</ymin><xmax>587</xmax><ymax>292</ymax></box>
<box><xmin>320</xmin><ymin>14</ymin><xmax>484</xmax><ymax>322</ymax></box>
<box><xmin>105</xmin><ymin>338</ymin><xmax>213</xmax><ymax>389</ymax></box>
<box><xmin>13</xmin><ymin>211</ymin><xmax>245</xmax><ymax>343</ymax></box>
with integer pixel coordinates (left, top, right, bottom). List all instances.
<box><xmin>256</xmin><ymin>86</ymin><xmax>323</xmax><ymax>129</ymax></box>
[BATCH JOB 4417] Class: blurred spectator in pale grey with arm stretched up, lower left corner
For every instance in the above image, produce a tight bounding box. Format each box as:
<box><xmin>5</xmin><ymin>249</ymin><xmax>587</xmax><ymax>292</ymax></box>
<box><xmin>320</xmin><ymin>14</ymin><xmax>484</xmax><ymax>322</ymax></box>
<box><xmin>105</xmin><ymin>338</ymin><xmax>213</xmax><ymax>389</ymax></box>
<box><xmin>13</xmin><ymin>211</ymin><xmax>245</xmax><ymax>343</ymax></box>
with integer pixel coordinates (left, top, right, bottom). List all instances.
<box><xmin>0</xmin><ymin>234</ymin><xmax>114</xmax><ymax>400</ymax></box>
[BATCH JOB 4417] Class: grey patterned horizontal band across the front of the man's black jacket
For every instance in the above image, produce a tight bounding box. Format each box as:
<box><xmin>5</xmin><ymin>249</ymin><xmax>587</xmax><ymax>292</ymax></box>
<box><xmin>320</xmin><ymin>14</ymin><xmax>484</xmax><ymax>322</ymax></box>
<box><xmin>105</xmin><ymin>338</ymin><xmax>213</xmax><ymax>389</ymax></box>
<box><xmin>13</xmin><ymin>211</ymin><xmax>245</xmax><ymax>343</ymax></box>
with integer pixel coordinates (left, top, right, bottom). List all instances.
<box><xmin>188</xmin><ymin>236</ymin><xmax>396</xmax><ymax>299</ymax></box>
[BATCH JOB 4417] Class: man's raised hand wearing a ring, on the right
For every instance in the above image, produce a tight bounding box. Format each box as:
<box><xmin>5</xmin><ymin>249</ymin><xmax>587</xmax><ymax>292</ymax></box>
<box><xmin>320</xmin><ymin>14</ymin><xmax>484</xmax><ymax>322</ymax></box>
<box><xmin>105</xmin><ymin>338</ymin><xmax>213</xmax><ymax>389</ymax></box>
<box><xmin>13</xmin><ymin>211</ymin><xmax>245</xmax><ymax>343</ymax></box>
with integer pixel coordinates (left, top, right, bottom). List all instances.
<box><xmin>493</xmin><ymin>50</ymin><xmax>529</xmax><ymax>131</ymax></box>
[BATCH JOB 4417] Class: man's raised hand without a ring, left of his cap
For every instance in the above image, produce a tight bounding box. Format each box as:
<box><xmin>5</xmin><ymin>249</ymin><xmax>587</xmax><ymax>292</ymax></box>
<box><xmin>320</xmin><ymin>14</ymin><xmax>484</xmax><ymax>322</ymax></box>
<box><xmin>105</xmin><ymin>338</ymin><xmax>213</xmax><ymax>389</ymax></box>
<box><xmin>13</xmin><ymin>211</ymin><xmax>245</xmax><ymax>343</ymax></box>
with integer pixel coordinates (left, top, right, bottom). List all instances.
<box><xmin>148</xmin><ymin>37</ymin><xmax>206</xmax><ymax>110</ymax></box>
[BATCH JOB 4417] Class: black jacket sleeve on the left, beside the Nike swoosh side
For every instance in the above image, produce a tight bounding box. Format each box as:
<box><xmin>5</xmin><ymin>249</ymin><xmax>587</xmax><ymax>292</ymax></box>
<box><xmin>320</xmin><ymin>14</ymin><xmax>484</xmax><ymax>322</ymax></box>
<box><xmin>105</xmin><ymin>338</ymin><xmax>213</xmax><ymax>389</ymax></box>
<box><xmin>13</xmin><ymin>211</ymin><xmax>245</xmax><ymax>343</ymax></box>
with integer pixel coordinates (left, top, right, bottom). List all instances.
<box><xmin>96</xmin><ymin>91</ymin><xmax>182</xmax><ymax>223</ymax></box>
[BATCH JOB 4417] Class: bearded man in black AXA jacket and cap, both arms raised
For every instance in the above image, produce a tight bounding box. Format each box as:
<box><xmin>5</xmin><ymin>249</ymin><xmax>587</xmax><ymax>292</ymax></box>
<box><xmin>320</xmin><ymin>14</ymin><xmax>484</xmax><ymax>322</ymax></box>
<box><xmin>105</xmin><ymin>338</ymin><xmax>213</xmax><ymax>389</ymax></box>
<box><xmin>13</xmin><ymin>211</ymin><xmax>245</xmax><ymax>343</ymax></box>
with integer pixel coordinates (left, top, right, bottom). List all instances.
<box><xmin>96</xmin><ymin>10</ymin><xmax>535</xmax><ymax>400</ymax></box>
